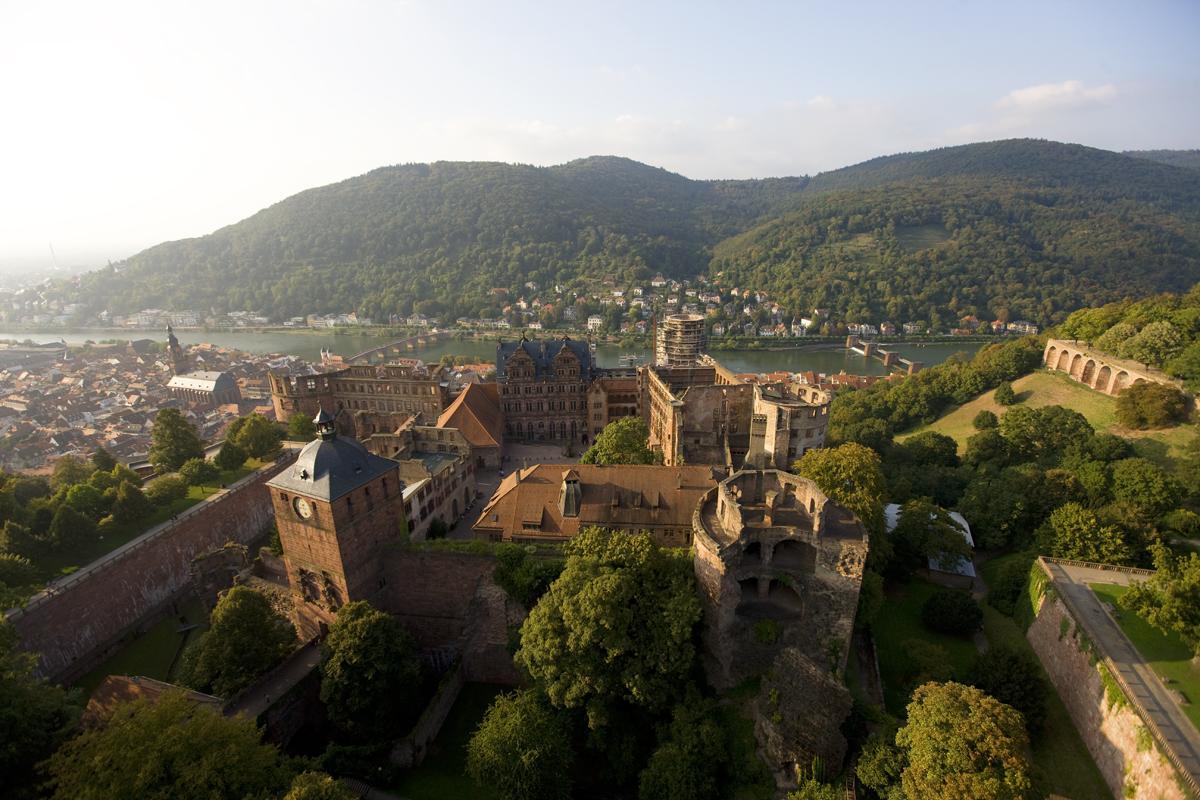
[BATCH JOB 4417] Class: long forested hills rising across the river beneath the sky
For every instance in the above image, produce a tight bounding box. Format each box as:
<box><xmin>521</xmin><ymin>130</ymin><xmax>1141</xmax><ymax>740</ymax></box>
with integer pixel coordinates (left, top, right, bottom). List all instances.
<box><xmin>68</xmin><ymin>140</ymin><xmax>1200</xmax><ymax>324</ymax></box>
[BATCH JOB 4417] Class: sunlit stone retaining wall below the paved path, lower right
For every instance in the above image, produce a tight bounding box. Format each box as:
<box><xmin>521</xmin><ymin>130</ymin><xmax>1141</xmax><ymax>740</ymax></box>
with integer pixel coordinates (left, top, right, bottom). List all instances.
<box><xmin>1027</xmin><ymin>595</ymin><xmax>1188</xmax><ymax>800</ymax></box>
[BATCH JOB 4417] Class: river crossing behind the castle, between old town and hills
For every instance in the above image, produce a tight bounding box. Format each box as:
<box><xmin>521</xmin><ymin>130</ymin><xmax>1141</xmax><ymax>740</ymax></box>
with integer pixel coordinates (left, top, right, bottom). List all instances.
<box><xmin>0</xmin><ymin>330</ymin><xmax>983</xmax><ymax>375</ymax></box>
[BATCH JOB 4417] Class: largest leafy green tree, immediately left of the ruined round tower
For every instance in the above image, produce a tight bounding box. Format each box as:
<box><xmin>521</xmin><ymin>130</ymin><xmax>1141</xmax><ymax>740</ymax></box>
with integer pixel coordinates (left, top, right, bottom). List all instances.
<box><xmin>516</xmin><ymin>528</ymin><xmax>700</xmax><ymax>729</ymax></box>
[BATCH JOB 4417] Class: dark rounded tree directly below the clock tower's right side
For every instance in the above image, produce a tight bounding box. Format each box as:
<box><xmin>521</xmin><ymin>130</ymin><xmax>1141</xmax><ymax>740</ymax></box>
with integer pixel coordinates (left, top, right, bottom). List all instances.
<box><xmin>320</xmin><ymin>600</ymin><xmax>421</xmax><ymax>739</ymax></box>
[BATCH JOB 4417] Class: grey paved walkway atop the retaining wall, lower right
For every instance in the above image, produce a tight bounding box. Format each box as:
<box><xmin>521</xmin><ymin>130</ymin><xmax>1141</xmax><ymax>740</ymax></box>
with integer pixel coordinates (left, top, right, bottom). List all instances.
<box><xmin>1044</xmin><ymin>559</ymin><xmax>1200</xmax><ymax>781</ymax></box>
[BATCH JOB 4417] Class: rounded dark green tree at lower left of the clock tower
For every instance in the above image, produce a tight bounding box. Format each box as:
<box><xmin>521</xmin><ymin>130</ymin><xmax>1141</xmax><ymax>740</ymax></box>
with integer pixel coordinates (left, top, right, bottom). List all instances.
<box><xmin>182</xmin><ymin>587</ymin><xmax>296</xmax><ymax>697</ymax></box>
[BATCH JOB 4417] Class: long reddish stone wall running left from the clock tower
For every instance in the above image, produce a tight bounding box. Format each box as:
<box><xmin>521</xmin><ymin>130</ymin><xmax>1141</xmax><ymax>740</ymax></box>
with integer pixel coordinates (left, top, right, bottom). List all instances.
<box><xmin>7</xmin><ymin>462</ymin><xmax>290</xmax><ymax>681</ymax></box>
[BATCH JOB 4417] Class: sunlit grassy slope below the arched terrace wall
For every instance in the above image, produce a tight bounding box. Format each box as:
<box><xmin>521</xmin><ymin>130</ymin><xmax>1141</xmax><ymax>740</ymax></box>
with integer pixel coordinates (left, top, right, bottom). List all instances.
<box><xmin>896</xmin><ymin>371</ymin><xmax>1194</xmax><ymax>468</ymax></box>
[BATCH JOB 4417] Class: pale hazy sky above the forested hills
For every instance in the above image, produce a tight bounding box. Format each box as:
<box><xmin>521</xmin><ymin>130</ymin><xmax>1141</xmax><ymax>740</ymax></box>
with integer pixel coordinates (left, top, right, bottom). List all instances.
<box><xmin>0</xmin><ymin>0</ymin><xmax>1200</xmax><ymax>269</ymax></box>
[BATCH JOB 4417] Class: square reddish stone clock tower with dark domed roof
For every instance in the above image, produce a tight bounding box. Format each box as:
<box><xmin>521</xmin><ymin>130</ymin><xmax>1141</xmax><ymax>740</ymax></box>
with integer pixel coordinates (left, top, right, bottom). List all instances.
<box><xmin>266</xmin><ymin>409</ymin><xmax>406</xmax><ymax>638</ymax></box>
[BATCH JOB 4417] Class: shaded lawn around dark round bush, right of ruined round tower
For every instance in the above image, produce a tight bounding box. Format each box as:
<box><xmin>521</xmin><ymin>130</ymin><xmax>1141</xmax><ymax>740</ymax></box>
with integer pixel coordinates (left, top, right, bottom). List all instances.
<box><xmin>871</xmin><ymin>578</ymin><xmax>976</xmax><ymax>717</ymax></box>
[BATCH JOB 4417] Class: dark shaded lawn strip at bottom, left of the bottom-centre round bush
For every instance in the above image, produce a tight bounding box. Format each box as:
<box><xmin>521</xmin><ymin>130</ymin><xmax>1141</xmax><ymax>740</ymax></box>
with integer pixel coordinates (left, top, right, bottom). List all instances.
<box><xmin>391</xmin><ymin>684</ymin><xmax>504</xmax><ymax>800</ymax></box>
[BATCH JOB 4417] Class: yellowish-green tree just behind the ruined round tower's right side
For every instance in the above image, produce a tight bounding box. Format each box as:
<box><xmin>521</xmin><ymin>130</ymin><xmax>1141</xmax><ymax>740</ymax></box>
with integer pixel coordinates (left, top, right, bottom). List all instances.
<box><xmin>792</xmin><ymin>443</ymin><xmax>886</xmax><ymax>537</ymax></box>
